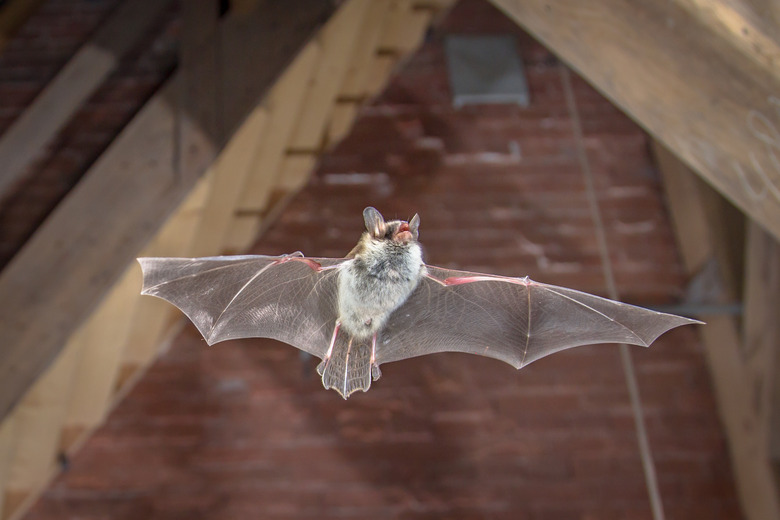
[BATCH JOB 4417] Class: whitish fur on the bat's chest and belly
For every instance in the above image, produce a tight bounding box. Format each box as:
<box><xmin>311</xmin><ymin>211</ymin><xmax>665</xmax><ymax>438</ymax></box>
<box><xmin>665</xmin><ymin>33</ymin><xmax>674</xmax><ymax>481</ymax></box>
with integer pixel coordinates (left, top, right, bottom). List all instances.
<box><xmin>339</xmin><ymin>243</ymin><xmax>424</xmax><ymax>338</ymax></box>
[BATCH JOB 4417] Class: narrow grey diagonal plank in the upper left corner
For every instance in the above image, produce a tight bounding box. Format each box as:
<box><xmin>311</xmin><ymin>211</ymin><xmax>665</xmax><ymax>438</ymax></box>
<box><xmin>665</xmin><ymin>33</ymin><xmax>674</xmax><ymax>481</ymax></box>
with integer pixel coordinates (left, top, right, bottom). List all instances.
<box><xmin>0</xmin><ymin>0</ymin><xmax>172</xmax><ymax>198</ymax></box>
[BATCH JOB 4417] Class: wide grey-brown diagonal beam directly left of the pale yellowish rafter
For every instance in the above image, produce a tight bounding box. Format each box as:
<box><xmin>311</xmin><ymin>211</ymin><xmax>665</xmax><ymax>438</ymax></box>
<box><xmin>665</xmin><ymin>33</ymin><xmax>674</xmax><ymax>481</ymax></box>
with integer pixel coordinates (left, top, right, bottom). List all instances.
<box><xmin>0</xmin><ymin>0</ymin><xmax>333</xmax><ymax>417</ymax></box>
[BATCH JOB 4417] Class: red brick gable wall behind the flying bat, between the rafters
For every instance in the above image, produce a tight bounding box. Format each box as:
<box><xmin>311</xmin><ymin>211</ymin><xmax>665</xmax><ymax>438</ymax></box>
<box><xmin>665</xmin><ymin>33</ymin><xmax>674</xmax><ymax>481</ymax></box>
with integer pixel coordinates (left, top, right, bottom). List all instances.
<box><xmin>28</xmin><ymin>0</ymin><xmax>740</xmax><ymax>520</ymax></box>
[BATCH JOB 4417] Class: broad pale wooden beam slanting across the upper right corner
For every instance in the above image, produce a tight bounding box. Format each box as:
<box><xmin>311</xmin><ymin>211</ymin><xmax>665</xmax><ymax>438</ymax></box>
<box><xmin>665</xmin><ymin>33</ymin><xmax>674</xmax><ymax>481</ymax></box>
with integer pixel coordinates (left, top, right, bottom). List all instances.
<box><xmin>492</xmin><ymin>0</ymin><xmax>780</xmax><ymax>242</ymax></box>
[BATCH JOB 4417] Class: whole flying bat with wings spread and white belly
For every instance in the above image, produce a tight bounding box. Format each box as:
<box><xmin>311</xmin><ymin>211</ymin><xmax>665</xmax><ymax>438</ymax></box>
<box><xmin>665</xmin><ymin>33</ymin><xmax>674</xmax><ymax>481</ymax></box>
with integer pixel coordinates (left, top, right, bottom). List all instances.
<box><xmin>138</xmin><ymin>207</ymin><xmax>701</xmax><ymax>399</ymax></box>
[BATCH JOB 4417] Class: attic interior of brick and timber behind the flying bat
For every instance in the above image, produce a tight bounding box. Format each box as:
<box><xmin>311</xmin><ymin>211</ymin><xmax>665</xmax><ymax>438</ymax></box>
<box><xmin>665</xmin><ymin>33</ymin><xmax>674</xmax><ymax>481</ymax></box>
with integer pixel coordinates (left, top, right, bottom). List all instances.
<box><xmin>0</xmin><ymin>0</ymin><xmax>780</xmax><ymax>520</ymax></box>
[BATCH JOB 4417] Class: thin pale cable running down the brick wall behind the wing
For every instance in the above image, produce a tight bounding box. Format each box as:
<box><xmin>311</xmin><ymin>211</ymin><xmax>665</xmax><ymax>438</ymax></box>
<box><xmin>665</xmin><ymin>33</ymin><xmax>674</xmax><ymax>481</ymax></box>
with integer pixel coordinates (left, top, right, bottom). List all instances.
<box><xmin>559</xmin><ymin>65</ymin><xmax>664</xmax><ymax>520</ymax></box>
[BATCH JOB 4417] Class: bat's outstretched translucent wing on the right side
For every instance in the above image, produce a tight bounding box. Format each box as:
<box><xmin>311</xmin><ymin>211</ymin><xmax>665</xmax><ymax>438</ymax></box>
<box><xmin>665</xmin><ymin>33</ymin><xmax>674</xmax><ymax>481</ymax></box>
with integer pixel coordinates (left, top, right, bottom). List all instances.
<box><xmin>376</xmin><ymin>266</ymin><xmax>700</xmax><ymax>368</ymax></box>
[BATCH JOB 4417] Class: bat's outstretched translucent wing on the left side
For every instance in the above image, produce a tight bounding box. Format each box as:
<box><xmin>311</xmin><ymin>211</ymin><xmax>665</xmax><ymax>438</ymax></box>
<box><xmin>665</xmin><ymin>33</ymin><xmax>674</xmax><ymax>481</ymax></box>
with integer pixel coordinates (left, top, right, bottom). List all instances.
<box><xmin>138</xmin><ymin>253</ymin><xmax>345</xmax><ymax>358</ymax></box>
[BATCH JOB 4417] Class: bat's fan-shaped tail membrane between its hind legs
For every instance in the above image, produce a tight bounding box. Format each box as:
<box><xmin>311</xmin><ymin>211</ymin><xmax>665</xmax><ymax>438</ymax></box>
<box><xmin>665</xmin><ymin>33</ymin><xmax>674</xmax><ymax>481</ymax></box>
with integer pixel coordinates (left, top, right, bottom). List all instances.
<box><xmin>317</xmin><ymin>329</ymin><xmax>371</xmax><ymax>399</ymax></box>
